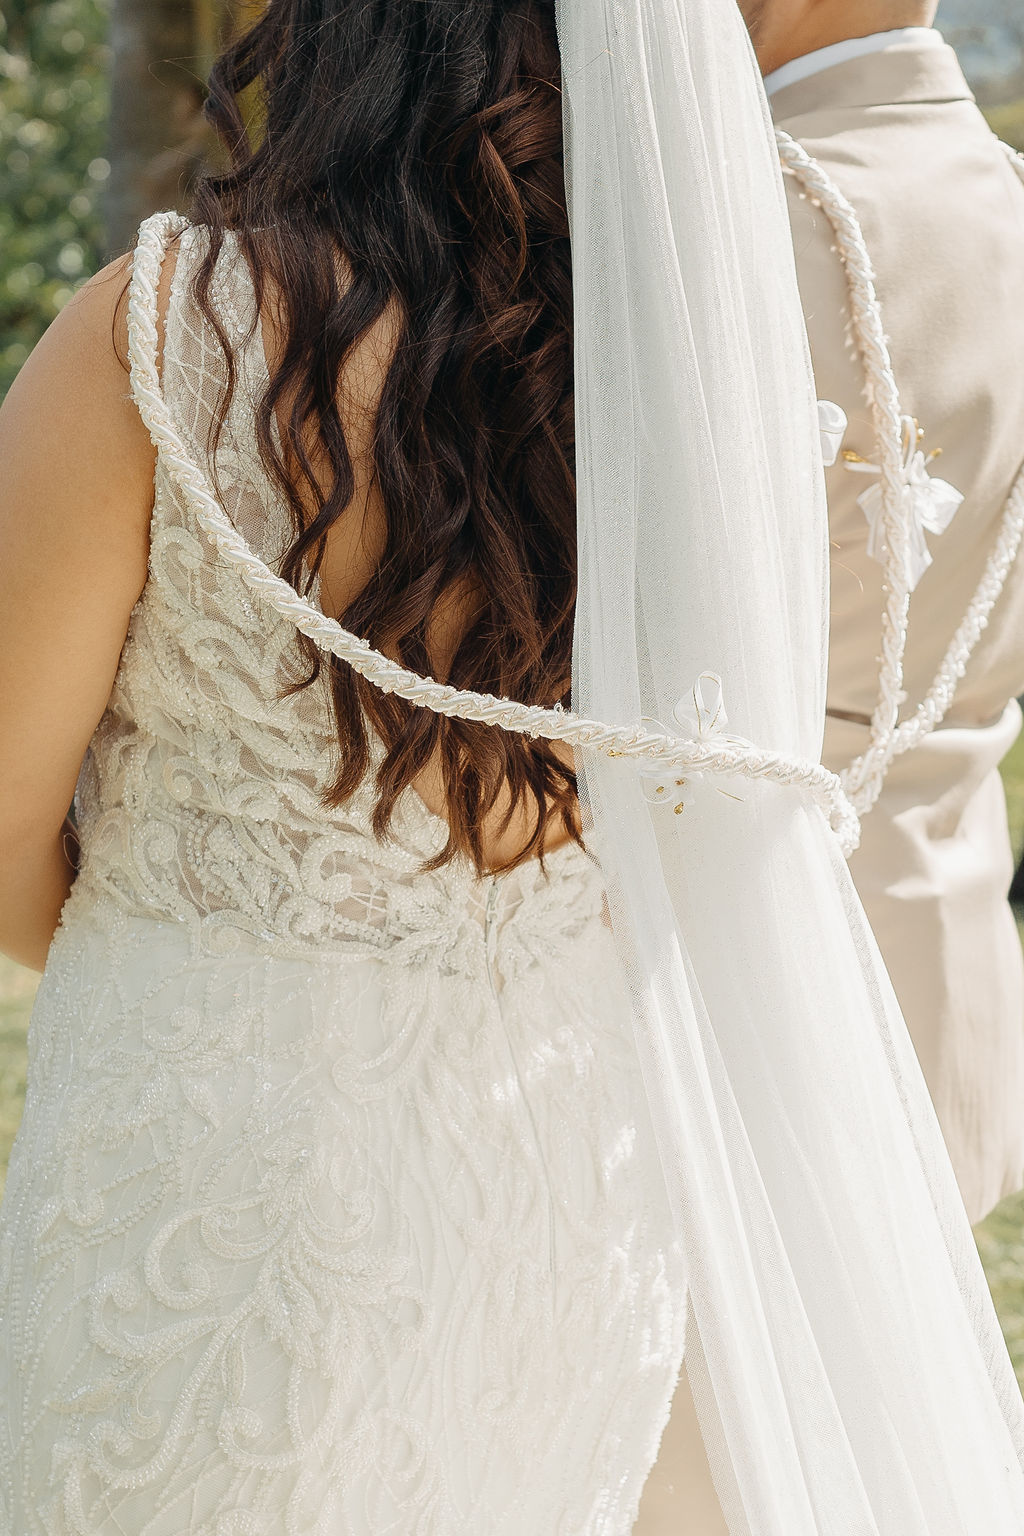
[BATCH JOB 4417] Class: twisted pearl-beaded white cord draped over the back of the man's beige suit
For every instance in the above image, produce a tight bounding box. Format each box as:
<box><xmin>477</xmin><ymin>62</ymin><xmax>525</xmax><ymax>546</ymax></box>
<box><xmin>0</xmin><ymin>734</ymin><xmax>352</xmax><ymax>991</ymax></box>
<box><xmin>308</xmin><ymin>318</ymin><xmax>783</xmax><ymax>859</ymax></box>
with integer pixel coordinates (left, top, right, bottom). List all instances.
<box><xmin>775</xmin><ymin>129</ymin><xmax>1024</xmax><ymax>817</ymax></box>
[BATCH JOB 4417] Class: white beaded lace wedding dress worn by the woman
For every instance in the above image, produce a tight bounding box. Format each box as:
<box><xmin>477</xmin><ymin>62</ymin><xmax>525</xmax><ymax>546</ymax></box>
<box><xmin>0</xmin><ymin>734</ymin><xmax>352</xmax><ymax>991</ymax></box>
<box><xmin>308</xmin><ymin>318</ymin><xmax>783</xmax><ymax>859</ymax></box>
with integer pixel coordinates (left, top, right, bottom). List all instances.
<box><xmin>0</xmin><ymin>233</ymin><xmax>685</xmax><ymax>1536</ymax></box>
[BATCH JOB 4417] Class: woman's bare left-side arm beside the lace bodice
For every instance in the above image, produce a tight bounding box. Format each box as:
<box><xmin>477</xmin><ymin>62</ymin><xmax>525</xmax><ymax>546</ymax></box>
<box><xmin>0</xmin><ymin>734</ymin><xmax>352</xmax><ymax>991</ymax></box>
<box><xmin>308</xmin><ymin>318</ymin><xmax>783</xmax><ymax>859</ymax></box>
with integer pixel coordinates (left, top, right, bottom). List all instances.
<box><xmin>0</xmin><ymin>261</ymin><xmax>154</xmax><ymax>969</ymax></box>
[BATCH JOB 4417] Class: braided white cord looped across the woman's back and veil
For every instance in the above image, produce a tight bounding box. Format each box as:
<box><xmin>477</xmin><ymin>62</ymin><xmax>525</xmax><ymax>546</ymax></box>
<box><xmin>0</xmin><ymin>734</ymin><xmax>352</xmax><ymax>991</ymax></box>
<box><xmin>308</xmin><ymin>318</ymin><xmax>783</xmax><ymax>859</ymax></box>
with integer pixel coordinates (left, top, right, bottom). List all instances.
<box><xmin>127</xmin><ymin>214</ymin><xmax>860</xmax><ymax>854</ymax></box>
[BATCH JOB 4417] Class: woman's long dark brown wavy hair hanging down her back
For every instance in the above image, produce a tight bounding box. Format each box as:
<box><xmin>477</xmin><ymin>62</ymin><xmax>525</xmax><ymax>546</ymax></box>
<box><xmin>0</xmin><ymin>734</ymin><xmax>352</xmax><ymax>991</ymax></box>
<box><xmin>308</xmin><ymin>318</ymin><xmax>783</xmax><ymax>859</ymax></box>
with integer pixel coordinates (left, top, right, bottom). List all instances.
<box><xmin>193</xmin><ymin>0</ymin><xmax>579</xmax><ymax>871</ymax></box>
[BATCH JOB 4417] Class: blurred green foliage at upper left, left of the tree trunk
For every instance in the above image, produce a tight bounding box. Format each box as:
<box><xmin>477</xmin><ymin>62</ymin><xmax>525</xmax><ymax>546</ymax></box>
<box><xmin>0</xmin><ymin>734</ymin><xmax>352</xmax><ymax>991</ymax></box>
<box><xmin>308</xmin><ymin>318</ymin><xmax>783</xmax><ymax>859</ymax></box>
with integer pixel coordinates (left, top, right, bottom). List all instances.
<box><xmin>0</xmin><ymin>0</ymin><xmax>109</xmax><ymax>395</ymax></box>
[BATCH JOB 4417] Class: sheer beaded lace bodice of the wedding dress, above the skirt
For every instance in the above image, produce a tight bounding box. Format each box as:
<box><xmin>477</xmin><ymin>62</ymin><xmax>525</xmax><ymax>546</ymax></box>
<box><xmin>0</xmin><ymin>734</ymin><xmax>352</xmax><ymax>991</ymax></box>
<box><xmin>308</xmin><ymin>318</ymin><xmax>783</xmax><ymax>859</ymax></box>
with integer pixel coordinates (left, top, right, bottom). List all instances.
<box><xmin>78</xmin><ymin>230</ymin><xmax>602</xmax><ymax>966</ymax></box>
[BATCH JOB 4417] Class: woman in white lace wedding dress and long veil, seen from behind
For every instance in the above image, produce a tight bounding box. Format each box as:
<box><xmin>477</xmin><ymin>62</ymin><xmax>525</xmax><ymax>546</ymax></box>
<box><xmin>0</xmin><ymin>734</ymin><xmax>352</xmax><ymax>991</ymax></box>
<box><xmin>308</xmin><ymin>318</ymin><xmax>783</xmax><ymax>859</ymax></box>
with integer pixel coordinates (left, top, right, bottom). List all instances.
<box><xmin>0</xmin><ymin>0</ymin><xmax>1024</xmax><ymax>1536</ymax></box>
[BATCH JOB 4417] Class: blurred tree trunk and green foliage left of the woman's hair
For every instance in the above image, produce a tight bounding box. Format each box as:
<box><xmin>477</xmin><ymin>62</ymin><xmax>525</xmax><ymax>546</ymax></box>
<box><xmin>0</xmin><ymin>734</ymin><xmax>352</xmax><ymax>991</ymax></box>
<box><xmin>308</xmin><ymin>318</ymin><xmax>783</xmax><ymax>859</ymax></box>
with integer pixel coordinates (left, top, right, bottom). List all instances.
<box><xmin>0</xmin><ymin>0</ymin><xmax>237</xmax><ymax>398</ymax></box>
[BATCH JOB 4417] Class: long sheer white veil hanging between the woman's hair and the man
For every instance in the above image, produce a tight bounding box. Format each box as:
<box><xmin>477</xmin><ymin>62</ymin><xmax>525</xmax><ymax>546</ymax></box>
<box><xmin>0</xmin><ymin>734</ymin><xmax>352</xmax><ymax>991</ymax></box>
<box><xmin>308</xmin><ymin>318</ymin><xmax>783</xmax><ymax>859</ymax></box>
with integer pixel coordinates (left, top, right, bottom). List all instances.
<box><xmin>559</xmin><ymin>0</ymin><xmax>1024</xmax><ymax>1536</ymax></box>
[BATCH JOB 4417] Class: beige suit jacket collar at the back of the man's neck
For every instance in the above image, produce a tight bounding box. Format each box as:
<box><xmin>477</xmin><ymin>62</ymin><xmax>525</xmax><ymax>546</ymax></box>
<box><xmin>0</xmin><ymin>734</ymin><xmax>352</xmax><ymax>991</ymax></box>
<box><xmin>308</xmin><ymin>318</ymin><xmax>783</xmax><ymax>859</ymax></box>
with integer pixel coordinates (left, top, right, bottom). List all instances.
<box><xmin>771</xmin><ymin>43</ymin><xmax>973</xmax><ymax>123</ymax></box>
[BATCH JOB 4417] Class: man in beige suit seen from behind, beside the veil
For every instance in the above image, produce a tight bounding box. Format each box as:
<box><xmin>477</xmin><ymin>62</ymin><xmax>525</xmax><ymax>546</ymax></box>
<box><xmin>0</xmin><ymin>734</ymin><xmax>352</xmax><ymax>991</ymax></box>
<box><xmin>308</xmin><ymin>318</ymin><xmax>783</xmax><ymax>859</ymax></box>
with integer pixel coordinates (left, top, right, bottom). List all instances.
<box><xmin>740</xmin><ymin>0</ymin><xmax>1024</xmax><ymax>1221</ymax></box>
